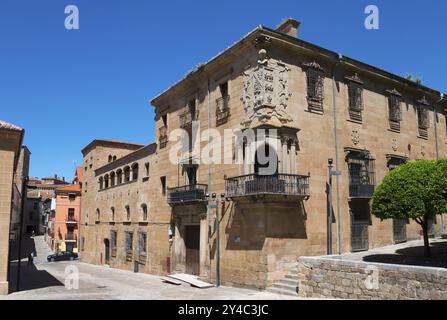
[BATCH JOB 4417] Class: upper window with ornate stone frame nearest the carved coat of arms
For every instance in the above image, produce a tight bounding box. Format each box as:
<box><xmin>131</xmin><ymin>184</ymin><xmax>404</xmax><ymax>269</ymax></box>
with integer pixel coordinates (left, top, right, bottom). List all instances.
<box><xmin>304</xmin><ymin>61</ymin><xmax>324</xmax><ymax>112</ymax></box>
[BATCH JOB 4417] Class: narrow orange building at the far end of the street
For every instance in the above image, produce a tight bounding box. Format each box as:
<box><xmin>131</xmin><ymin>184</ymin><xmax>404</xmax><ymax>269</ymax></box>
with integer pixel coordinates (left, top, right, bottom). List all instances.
<box><xmin>52</xmin><ymin>168</ymin><xmax>82</xmax><ymax>252</ymax></box>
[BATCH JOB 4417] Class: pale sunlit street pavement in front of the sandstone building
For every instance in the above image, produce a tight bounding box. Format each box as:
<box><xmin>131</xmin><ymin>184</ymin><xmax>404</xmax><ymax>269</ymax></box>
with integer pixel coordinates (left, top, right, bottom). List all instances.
<box><xmin>0</xmin><ymin>237</ymin><xmax>300</xmax><ymax>300</ymax></box>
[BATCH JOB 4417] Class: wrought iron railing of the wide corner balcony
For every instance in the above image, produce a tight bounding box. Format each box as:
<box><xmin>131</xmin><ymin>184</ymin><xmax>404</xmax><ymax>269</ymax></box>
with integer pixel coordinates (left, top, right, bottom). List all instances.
<box><xmin>225</xmin><ymin>174</ymin><xmax>309</xmax><ymax>198</ymax></box>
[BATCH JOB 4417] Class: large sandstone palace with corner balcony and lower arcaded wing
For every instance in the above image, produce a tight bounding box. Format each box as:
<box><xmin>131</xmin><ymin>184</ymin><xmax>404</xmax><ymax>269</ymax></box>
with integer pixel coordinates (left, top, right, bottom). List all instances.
<box><xmin>80</xmin><ymin>19</ymin><xmax>447</xmax><ymax>288</ymax></box>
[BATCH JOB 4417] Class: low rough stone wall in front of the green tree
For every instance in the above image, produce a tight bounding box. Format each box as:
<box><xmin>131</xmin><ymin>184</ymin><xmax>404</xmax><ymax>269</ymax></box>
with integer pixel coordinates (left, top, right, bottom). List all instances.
<box><xmin>298</xmin><ymin>256</ymin><xmax>447</xmax><ymax>300</ymax></box>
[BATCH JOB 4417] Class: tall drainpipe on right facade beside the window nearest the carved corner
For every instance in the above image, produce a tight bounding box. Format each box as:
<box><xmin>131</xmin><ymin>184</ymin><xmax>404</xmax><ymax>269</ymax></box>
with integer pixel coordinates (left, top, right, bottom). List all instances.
<box><xmin>332</xmin><ymin>54</ymin><xmax>343</xmax><ymax>255</ymax></box>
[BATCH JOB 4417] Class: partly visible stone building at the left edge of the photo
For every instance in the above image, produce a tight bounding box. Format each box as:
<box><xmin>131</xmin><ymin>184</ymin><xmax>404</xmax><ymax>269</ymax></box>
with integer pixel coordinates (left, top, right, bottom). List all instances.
<box><xmin>0</xmin><ymin>120</ymin><xmax>28</xmax><ymax>294</ymax></box>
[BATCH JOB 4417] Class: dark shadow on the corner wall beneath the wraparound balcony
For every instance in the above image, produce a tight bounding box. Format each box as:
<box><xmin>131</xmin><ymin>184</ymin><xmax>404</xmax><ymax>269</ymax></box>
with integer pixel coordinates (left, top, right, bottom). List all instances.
<box><xmin>224</xmin><ymin>202</ymin><xmax>307</xmax><ymax>250</ymax></box>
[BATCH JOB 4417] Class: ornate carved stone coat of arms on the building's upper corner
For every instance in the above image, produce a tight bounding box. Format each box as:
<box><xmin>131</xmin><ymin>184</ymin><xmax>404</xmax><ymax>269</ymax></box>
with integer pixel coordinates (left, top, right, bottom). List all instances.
<box><xmin>241</xmin><ymin>49</ymin><xmax>292</xmax><ymax>128</ymax></box>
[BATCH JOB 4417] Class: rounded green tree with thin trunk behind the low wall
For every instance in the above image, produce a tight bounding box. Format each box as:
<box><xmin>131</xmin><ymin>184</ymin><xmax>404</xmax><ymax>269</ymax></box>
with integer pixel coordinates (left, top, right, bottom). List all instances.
<box><xmin>371</xmin><ymin>160</ymin><xmax>447</xmax><ymax>257</ymax></box>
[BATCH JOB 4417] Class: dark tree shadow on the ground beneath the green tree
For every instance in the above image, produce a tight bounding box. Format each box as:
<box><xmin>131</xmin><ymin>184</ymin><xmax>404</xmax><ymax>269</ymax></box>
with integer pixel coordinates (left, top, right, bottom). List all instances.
<box><xmin>363</xmin><ymin>242</ymin><xmax>447</xmax><ymax>268</ymax></box>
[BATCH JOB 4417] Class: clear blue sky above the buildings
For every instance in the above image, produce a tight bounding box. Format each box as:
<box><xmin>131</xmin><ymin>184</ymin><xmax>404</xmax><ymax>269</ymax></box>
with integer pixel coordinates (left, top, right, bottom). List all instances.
<box><xmin>0</xmin><ymin>0</ymin><xmax>447</xmax><ymax>179</ymax></box>
